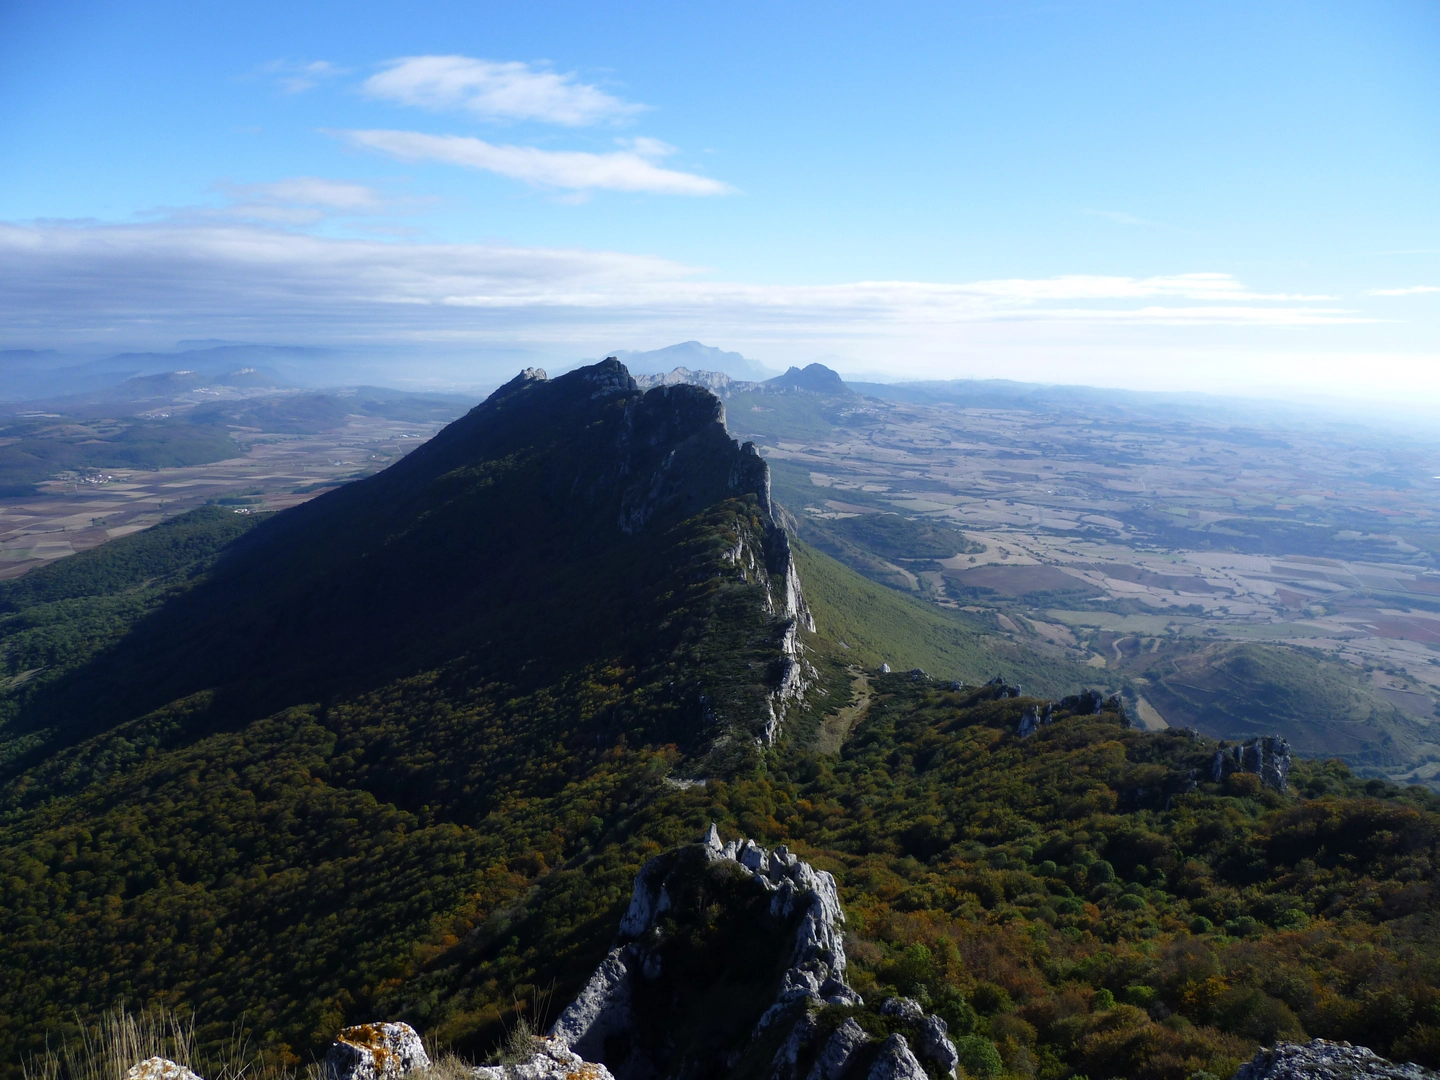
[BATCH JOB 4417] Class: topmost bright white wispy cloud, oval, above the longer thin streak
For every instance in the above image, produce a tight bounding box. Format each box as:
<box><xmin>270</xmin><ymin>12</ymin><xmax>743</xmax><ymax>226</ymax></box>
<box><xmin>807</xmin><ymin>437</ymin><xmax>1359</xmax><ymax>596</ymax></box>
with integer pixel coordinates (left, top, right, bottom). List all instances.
<box><xmin>364</xmin><ymin>56</ymin><xmax>645</xmax><ymax>127</ymax></box>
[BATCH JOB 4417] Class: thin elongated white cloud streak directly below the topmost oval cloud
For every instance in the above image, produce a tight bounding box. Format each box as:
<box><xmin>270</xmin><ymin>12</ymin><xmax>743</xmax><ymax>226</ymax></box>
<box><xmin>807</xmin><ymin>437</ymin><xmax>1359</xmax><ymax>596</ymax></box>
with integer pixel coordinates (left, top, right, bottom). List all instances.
<box><xmin>337</xmin><ymin>131</ymin><xmax>734</xmax><ymax>194</ymax></box>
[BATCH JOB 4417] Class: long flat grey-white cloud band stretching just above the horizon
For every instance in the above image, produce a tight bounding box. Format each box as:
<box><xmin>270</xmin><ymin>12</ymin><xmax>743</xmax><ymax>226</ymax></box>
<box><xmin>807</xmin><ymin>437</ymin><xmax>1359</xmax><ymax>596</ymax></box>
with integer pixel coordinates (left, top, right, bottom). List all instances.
<box><xmin>0</xmin><ymin>224</ymin><xmax>1372</xmax><ymax>351</ymax></box>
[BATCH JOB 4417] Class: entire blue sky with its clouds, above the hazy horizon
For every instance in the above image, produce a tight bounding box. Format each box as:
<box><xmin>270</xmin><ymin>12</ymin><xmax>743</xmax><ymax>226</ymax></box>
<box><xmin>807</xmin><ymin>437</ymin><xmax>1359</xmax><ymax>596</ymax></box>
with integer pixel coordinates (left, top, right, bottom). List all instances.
<box><xmin>0</xmin><ymin>1</ymin><xmax>1440</xmax><ymax>400</ymax></box>
